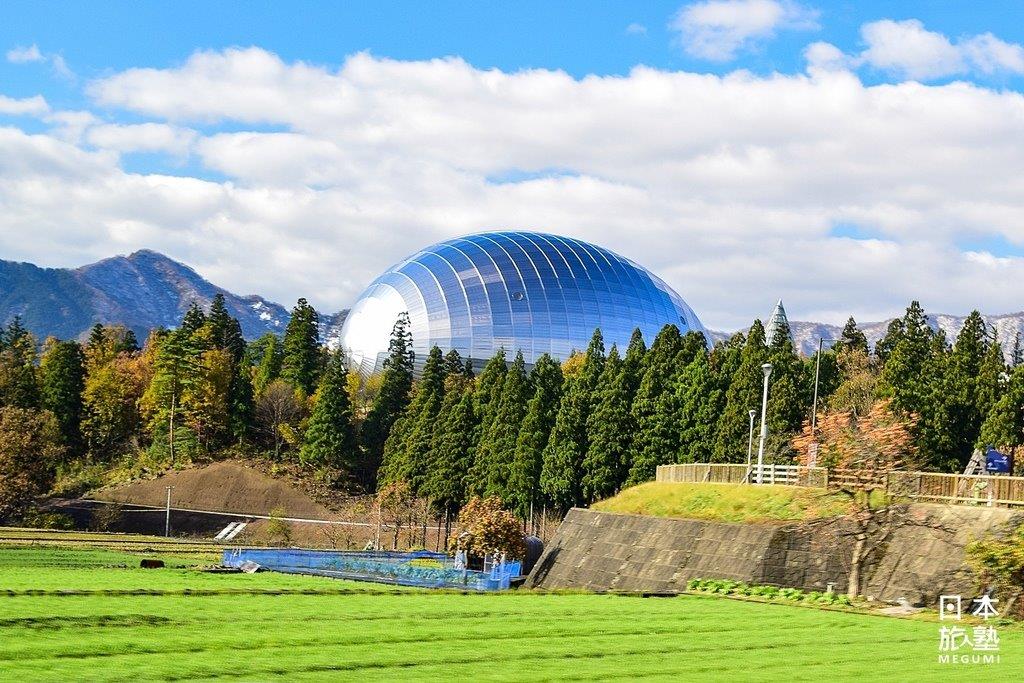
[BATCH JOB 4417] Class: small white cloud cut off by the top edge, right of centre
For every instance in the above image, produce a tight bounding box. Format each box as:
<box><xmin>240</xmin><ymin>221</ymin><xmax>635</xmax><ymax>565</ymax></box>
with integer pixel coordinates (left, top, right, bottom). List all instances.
<box><xmin>669</xmin><ymin>0</ymin><xmax>818</xmax><ymax>61</ymax></box>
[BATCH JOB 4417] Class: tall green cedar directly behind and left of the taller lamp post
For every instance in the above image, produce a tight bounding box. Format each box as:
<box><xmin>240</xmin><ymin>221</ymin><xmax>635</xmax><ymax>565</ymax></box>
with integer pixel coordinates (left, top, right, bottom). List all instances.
<box><xmin>714</xmin><ymin>321</ymin><xmax>777</xmax><ymax>463</ymax></box>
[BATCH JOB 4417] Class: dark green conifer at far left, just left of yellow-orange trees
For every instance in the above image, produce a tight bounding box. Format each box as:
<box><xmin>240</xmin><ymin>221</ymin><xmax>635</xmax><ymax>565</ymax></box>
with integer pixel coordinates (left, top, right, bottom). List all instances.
<box><xmin>39</xmin><ymin>339</ymin><xmax>85</xmax><ymax>457</ymax></box>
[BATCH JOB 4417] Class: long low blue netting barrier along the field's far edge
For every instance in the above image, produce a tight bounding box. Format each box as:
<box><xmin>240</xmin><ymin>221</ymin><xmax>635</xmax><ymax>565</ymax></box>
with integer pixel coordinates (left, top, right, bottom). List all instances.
<box><xmin>223</xmin><ymin>548</ymin><xmax>521</xmax><ymax>591</ymax></box>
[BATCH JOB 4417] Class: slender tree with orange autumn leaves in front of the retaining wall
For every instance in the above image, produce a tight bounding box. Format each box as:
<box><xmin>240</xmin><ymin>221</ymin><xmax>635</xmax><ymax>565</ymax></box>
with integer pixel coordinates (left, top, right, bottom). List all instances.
<box><xmin>793</xmin><ymin>400</ymin><xmax>918</xmax><ymax>597</ymax></box>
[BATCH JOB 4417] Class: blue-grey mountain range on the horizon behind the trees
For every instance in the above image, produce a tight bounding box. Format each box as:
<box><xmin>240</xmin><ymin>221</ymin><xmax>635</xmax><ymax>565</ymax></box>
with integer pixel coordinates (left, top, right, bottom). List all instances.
<box><xmin>0</xmin><ymin>249</ymin><xmax>1024</xmax><ymax>355</ymax></box>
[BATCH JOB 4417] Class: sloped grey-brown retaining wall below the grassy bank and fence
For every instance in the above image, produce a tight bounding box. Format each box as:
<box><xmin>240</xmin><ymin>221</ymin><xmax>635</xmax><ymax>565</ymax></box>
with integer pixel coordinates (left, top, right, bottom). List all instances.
<box><xmin>527</xmin><ymin>505</ymin><xmax>1021</xmax><ymax>604</ymax></box>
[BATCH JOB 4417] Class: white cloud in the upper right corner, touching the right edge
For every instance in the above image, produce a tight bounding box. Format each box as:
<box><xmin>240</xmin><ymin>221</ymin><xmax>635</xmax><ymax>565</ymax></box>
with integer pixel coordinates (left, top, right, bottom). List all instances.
<box><xmin>857</xmin><ymin>19</ymin><xmax>1024</xmax><ymax>80</ymax></box>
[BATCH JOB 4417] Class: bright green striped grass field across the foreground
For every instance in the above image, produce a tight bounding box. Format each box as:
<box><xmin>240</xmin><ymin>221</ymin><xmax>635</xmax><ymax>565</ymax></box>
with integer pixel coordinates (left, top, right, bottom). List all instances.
<box><xmin>0</xmin><ymin>546</ymin><xmax>1024</xmax><ymax>681</ymax></box>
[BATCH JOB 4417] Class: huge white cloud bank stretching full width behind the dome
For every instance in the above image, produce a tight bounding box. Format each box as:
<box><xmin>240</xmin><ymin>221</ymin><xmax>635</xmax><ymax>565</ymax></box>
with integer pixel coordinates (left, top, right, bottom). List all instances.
<box><xmin>6</xmin><ymin>46</ymin><xmax>1024</xmax><ymax>328</ymax></box>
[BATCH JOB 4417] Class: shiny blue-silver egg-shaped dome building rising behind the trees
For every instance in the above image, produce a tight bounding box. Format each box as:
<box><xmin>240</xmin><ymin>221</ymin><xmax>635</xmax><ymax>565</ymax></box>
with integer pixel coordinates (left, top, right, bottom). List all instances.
<box><xmin>341</xmin><ymin>231</ymin><xmax>707</xmax><ymax>375</ymax></box>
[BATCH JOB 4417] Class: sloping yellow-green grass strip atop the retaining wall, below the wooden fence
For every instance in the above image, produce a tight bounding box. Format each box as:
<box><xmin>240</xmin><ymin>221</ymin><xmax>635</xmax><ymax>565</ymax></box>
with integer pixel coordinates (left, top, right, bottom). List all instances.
<box><xmin>592</xmin><ymin>481</ymin><xmax>849</xmax><ymax>522</ymax></box>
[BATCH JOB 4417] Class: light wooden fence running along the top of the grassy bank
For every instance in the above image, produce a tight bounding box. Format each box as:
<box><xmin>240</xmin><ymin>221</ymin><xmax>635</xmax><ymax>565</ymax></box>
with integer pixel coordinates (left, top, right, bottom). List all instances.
<box><xmin>655</xmin><ymin>463</ymin><xmax>1024</xmax><ymax>507</ymax></box>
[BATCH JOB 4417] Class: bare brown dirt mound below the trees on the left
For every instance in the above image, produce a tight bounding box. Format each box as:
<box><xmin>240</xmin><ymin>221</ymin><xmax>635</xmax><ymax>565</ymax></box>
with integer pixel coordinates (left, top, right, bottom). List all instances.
<box><xmin>92</xmin><ymin>460</ymin><xmax>336</xmax><ymax>519</ymax></box>
